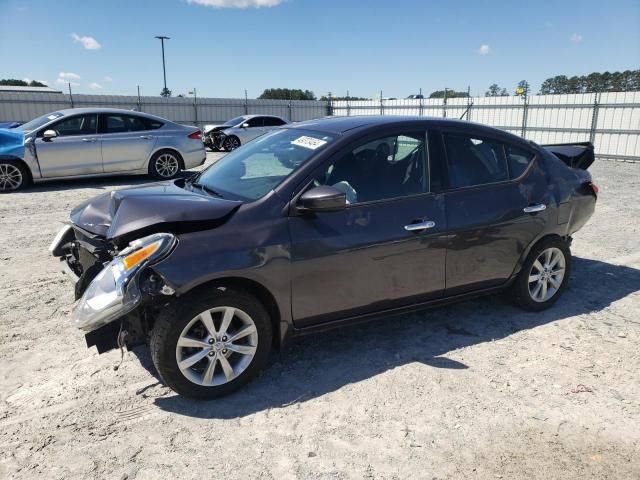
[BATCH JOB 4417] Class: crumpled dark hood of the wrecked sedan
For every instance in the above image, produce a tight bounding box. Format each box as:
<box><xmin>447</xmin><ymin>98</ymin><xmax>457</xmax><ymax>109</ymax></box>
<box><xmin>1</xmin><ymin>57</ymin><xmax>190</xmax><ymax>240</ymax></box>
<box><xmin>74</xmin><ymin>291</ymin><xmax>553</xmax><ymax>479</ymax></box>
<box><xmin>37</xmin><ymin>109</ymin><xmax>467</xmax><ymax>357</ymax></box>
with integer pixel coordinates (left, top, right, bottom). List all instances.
<box><xmin>71</xmin><ymin>180</ymin><xmax>242</xmax><ymax>240</ymax></box>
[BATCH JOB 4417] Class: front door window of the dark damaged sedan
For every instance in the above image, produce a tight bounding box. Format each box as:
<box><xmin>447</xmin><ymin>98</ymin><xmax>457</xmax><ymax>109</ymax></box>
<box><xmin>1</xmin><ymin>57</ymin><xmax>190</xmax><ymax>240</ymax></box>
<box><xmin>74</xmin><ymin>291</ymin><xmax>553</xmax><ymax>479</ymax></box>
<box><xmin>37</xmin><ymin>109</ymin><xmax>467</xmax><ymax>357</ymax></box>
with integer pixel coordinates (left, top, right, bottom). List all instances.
<box><xmin>316</xmin><ymin>132</ymin><xmax>429</xmax><ymax>204</ymax></box>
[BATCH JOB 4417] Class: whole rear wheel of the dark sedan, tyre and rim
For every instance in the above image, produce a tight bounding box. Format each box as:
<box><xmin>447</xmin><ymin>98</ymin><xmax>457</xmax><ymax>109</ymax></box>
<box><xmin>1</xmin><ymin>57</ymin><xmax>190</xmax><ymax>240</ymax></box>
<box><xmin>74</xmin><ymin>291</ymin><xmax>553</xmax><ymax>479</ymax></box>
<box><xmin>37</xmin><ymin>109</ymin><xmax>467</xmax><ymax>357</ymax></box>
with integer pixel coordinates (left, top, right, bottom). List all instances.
<box><xmin>512</xmin><ymin>237</ymin><xmax>571</xmax><ymax>311</ymax></box>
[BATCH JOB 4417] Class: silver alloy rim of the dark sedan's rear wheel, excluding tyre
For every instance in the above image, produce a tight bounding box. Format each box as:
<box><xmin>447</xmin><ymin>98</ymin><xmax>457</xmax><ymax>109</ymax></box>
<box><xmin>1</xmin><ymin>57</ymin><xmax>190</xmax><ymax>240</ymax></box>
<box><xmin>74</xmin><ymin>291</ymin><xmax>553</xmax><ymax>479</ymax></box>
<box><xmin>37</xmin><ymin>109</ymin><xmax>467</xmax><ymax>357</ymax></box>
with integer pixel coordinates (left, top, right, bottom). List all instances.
<box><xmin>529</xmin><ymin>247</ymin><xmax>566</xmax><ymax>303</ymax></box>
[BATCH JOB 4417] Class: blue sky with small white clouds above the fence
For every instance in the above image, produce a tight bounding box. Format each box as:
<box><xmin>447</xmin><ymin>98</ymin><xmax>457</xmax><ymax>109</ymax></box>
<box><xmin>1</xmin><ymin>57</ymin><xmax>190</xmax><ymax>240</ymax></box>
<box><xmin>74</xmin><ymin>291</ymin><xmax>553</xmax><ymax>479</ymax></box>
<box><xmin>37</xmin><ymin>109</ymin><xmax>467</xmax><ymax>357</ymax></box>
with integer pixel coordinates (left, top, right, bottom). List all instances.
<box><xmin>0</xmin><ymin>0</ymin><xmax>640</xmax><ymax>98</ymax></box>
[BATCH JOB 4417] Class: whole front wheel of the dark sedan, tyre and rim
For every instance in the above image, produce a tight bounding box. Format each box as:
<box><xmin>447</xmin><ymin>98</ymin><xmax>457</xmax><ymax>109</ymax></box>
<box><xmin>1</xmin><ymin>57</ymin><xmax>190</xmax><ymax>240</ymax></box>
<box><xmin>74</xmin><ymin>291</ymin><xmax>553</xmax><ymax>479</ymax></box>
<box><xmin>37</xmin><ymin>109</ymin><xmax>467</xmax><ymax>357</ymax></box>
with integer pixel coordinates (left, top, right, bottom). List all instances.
<box><xmin>151</xmin><ymin>290</ymin><xmax>272</xmax><ymax>399</ymax></box>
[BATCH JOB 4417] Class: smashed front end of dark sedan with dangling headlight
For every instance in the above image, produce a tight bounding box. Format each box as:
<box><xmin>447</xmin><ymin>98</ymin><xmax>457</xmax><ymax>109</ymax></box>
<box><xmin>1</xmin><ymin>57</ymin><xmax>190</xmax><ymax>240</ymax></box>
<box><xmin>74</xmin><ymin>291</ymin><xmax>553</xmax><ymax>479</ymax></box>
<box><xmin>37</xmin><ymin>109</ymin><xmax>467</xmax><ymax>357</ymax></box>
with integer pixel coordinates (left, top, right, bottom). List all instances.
<box><xmin>49</xmin><ymin>225</ymin><xmax>178</xmax><ymax>353</ymax></box>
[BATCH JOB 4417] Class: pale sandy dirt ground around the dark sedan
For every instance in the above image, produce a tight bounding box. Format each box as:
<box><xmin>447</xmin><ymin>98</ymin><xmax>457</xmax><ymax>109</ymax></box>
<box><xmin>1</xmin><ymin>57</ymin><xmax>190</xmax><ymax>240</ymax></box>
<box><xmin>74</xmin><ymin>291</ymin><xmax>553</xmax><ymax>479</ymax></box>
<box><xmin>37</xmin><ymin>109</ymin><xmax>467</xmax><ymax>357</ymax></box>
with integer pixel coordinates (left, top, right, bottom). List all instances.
<box><xmin>0</xmin><ymin>155</ymin><xmax>640</xmax><ymax>479</ymax></box>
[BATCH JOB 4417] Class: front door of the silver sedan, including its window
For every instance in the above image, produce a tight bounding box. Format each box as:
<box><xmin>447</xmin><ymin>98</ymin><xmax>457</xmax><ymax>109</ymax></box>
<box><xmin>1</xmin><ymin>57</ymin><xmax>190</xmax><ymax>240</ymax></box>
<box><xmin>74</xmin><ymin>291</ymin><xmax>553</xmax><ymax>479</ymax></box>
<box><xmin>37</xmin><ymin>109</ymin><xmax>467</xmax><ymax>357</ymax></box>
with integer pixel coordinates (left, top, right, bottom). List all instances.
<box><xmin>35</xmin><ymin>113</ymin><xmax>102</xmax><ymax>178</ymax></box>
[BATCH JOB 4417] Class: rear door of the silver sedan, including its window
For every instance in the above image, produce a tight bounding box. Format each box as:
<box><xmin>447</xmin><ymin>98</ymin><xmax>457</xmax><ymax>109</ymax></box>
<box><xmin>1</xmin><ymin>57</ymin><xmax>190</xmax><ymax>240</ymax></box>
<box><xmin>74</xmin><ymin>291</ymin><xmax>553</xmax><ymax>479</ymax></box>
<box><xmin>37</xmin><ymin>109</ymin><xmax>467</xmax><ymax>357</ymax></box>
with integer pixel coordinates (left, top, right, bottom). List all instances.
<box><xmin>98</xmin><ymin>113</ymin><xmax>157</xmax><ymax>173</ymax></box>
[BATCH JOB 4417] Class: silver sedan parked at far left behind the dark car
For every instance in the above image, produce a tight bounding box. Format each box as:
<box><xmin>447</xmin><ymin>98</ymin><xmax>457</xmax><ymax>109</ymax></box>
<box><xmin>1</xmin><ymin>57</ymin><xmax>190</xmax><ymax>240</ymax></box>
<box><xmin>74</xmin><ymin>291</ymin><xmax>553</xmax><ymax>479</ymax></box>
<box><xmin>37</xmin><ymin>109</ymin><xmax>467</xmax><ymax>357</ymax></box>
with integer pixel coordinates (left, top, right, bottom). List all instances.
<box><xmin>0</xmin><ymin>108</ymin><xmax>206</xmax><ymax>192</ymax></box>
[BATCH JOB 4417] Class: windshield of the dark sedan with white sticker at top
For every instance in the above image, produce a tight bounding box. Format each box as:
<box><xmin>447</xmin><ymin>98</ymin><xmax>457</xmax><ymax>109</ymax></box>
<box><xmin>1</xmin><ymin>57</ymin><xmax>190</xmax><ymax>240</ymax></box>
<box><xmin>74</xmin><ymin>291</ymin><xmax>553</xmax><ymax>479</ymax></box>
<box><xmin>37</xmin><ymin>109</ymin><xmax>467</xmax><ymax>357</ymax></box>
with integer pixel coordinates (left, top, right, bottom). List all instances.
<box><xmin>197</xmin><ymin>129</ymin><xmax>334</xmax><ymax>201</ymax></box>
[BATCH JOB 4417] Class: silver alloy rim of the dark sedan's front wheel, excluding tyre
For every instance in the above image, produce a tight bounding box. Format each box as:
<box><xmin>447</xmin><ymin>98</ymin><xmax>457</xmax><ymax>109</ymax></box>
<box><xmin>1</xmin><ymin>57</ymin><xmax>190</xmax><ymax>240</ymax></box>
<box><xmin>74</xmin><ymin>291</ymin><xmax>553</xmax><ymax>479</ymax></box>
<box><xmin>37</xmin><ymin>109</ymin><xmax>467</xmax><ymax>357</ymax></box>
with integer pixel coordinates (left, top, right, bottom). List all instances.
<box><xmin>176</xmin><ymin>307</ymin><xmax>258</xmax><ymax>387</ymax></box>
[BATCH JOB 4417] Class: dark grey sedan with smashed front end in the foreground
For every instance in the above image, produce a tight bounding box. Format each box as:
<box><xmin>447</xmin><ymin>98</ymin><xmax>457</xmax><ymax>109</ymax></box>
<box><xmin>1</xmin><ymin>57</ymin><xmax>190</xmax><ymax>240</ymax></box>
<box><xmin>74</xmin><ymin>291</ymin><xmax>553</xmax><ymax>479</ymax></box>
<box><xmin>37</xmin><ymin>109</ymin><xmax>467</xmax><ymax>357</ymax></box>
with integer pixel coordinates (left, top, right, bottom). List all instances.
<box><xmin>51</xmin><ymin>117</ymin><xmax>598</xmax><ymax>398</ymax></box>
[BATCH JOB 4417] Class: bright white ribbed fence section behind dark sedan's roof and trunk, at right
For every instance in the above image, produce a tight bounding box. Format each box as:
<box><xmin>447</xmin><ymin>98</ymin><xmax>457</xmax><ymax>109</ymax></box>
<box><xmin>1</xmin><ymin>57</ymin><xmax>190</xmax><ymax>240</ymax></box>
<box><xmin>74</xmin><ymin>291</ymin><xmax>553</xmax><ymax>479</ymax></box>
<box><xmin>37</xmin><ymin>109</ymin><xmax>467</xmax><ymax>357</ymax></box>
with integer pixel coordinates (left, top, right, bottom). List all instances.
<box><xmin>331</xmin><ymin>92</ymin><xmax>640</xmax><ymax>161</ymax></box>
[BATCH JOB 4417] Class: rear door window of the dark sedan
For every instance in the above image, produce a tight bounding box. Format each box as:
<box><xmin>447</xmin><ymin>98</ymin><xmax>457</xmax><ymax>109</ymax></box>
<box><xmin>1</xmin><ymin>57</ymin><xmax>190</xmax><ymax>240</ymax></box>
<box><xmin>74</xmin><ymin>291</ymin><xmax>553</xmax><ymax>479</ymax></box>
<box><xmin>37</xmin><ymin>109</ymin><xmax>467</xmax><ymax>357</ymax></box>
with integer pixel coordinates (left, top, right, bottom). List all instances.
<box><xmin>444</xmin><ymin>134</ymin><xmax>509</xmax><ymax>188</ymax></box>
